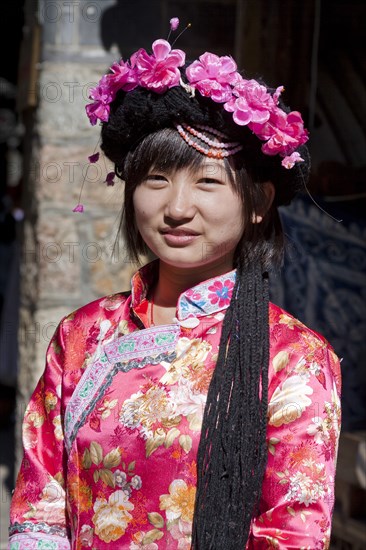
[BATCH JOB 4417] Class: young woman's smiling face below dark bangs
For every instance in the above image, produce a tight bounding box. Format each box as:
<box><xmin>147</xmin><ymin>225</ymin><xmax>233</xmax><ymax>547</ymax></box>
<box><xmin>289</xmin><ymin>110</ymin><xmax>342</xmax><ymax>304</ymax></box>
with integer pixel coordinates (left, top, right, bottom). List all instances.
<box><xmin>133</xmin><ymin>159</ymin><xmax>244</xmax><ymax>276</ymax></box>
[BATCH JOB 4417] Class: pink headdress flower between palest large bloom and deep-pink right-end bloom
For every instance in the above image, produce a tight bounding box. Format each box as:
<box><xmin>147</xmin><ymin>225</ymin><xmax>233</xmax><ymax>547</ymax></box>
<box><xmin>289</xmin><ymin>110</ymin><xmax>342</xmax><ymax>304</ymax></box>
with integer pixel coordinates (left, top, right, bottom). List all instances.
<box><xmin>224</xmin><ymin>80</ymin><xmax>276</xmax><ymax>126</ymax></box>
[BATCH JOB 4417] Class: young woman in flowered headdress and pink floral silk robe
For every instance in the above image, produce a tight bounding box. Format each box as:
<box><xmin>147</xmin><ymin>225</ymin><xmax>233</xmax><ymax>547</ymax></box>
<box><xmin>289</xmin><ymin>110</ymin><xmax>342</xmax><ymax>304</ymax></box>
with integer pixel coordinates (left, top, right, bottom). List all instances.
<box><xmin>10</xmin><ymin>29</ymin><xmax>340</xmax><ymax>550</ymax></box>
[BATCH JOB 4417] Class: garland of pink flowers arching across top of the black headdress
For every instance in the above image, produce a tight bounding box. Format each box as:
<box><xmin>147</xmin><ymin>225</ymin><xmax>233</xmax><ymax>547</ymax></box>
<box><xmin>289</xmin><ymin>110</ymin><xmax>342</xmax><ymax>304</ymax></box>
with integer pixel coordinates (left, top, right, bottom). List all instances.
<box><xmin>86</xmin><ymin>18</ymin><xmax>308</xmax><ymax>169</ymax></box>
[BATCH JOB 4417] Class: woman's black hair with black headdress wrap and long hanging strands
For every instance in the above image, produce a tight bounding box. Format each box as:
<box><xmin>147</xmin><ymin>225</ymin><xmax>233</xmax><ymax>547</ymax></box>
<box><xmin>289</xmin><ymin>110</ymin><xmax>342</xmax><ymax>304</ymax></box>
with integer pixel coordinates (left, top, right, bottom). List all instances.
<box><xmin>101</xmin><ymin>80</ymin><xmax>310</xmax><ymax>550</ymax></box>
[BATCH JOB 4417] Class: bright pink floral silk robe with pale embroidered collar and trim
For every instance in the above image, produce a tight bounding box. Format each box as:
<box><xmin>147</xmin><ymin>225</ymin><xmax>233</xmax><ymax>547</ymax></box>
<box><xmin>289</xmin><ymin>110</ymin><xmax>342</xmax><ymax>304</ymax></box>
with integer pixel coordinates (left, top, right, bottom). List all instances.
<box><xmin>9</xmin><ymin>264</ymin><xmax>340</xmax><ymax>550</ymax></box>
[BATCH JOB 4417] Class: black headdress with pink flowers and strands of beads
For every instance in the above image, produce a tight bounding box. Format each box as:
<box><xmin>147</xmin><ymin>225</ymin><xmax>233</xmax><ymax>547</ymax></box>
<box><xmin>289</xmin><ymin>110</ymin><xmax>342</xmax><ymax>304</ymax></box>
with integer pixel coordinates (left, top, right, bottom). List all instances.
<box><xmin>74</xmin><ymin>18</ymin><xmax>308</xmax><ymax>212</ymax></box>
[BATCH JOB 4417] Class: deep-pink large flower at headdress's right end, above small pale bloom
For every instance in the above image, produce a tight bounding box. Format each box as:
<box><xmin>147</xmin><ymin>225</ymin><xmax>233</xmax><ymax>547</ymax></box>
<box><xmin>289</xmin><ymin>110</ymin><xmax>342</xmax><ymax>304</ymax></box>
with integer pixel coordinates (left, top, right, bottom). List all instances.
<box><xmin>253</xmin><ymin>108</ymin><xmax>309</xmax><ymax>157</ymax></box>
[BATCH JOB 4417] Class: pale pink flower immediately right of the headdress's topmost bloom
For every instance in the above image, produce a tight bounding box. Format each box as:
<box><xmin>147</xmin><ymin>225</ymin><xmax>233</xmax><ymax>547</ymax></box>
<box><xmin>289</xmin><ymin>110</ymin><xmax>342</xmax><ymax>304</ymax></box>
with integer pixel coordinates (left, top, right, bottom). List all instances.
<box><xmin>186</xmin><ymin>52</ymin><xmax>241</xmax><ymax>103</ymax></box>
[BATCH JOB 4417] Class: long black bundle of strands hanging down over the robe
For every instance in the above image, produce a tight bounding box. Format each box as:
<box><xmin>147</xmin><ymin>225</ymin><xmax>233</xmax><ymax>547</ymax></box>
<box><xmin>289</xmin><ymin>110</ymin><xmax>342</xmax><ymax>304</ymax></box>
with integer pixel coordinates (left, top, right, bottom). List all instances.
<box><xmin>192</xmin><ymin>263</ymin><xmax>269</xmax><ymax>550</ymax></box>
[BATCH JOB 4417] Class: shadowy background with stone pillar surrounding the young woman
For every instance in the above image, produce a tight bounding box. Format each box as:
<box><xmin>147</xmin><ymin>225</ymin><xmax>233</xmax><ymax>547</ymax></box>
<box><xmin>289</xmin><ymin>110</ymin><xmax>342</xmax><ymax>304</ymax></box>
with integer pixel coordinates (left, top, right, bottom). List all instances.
<box><xmin>0</xmin><ymin>0</ymin><xmax>366</xmax><ymax>550</ymax></box>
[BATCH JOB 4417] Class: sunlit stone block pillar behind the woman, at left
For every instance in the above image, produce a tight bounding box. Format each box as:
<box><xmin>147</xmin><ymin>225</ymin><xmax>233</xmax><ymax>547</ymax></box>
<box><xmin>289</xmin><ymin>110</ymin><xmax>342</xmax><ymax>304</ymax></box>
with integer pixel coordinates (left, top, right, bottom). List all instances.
<box><xmin>18</xmin><ymin>0</ymin><xmax>135</xmax><ymax>426</ymax></box>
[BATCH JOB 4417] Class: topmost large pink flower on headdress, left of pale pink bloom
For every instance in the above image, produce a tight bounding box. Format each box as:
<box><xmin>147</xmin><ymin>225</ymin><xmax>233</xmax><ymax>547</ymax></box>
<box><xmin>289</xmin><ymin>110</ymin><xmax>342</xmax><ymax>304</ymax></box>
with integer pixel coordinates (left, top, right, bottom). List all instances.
<box><xmin>131</xmin><ymin>40</ymin><xmax>186</xmax><ymax>94</ymax></box>
